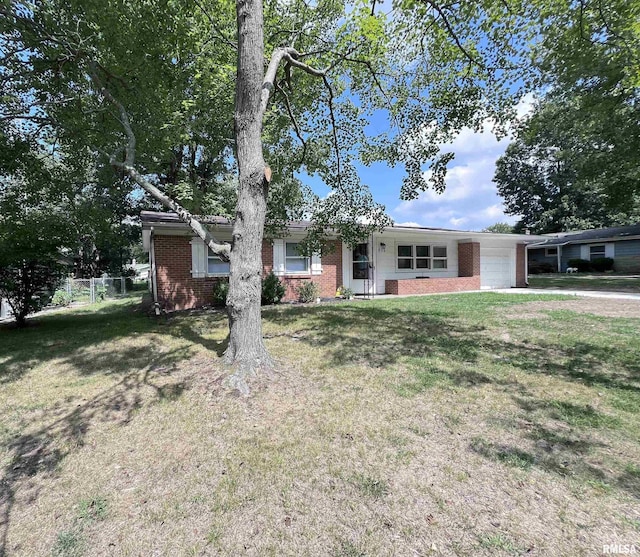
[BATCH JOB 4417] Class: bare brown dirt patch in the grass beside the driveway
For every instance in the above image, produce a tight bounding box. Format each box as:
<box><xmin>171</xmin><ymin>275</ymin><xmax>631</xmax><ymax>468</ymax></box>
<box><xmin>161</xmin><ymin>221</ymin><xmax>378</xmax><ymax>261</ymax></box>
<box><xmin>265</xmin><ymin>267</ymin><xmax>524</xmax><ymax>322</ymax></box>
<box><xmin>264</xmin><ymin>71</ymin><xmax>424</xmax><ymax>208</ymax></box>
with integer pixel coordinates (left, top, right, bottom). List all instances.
<box><xmin>506</xmin><ymin>298</ymin><xmax>640</xmax><ymax>319</ymax></box>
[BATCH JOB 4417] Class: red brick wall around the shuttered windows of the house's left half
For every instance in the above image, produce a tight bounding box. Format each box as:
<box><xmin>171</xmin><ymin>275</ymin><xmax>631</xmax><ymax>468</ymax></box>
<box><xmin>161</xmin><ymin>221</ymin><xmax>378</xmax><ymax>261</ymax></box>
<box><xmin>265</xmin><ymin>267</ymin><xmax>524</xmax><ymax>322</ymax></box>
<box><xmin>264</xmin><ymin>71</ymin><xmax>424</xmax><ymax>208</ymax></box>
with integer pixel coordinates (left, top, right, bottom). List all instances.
<box><xmin>153</xmin><ymin>236</ymin><xmax>342</xmax><ymax>310</ymax></box>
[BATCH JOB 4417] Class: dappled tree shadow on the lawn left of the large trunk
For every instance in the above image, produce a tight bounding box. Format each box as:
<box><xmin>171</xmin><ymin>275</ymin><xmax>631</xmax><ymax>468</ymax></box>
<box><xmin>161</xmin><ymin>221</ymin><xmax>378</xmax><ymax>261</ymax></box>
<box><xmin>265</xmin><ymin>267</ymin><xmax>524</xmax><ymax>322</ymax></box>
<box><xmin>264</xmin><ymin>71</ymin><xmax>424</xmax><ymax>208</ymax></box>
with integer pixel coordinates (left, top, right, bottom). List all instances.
<box><xmin>0</xmin><ymin>298</ymin><xmax>229</xmax><ymax>556</ymax></box>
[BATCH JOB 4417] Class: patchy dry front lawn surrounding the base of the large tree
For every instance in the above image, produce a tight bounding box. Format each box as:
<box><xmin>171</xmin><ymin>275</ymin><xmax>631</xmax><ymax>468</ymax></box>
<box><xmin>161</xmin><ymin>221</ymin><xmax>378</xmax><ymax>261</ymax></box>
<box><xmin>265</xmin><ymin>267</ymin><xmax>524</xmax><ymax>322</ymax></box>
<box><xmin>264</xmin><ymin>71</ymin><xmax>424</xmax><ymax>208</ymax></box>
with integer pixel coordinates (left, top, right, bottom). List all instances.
<box><xmin>0</xmin><ymin>293</ymin><xmax>640</xmax><ymax>557</ymax></box>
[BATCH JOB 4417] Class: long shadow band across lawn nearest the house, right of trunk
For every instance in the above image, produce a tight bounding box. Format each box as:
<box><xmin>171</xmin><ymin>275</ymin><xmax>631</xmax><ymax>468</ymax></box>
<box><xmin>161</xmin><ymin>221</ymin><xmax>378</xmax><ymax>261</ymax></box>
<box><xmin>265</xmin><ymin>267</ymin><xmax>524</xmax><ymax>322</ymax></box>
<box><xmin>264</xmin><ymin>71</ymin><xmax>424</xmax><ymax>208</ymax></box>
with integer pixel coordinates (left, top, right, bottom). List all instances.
<box><xmin>263</xmin><ymin>303</ymin><xmax>640</xmax><ymax>396</ymax></box>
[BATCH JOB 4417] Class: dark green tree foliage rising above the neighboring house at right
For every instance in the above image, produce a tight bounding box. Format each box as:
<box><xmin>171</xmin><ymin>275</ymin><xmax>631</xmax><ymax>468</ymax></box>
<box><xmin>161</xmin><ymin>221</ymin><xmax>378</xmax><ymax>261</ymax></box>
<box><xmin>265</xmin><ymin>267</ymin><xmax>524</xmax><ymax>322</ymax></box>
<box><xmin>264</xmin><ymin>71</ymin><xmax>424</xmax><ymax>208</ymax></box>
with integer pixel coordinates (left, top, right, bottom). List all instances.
<box><xmin>495</xmin><ymin>0</ymin><xmax>640</xmax><ymax>232</ymax></box>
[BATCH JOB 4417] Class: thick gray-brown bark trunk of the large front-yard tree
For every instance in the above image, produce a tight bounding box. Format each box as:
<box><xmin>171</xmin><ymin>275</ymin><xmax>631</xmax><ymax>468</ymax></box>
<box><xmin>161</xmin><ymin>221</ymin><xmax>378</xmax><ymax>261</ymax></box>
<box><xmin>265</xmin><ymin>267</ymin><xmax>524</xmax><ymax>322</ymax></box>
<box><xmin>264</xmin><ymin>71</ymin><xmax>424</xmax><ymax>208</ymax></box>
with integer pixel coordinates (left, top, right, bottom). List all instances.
<box><xmin>225</xmin><ymin>0</ymin><xmax>272</xmax><ymax>390</ymax></box>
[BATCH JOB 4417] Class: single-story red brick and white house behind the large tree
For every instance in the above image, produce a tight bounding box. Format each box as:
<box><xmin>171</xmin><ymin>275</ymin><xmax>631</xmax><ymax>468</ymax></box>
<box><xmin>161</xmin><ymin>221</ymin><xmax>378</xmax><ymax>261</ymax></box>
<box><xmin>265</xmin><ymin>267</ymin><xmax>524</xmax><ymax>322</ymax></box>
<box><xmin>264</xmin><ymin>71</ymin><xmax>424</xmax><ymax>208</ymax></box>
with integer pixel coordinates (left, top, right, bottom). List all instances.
<box><xmin>141</xmin><ymin>211</ymin><xmax>543</xmax><ymax>310</ymax></box>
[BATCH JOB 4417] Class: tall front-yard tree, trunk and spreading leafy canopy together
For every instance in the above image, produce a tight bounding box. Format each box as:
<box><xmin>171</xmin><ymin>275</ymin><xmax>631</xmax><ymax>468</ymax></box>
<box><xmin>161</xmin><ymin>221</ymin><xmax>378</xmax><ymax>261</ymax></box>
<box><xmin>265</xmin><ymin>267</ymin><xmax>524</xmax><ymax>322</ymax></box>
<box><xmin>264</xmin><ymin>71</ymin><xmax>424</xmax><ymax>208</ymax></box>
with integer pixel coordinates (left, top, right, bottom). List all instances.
<box><xmin>0</xmin><ymin>0</ymin><xmax>536</xmax><ymax>386</ymax></box>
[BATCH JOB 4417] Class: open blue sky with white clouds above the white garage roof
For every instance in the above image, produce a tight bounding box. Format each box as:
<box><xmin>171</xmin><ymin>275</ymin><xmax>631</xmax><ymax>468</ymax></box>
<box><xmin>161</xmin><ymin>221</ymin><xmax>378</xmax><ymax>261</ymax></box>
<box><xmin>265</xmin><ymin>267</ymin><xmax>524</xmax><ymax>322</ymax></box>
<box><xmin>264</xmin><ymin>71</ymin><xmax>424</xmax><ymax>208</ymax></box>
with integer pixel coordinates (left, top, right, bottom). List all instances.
<box><xmin>302</xmin><ymin>96</ymin><xmax>532</xmax><ymax>230</ymax></box>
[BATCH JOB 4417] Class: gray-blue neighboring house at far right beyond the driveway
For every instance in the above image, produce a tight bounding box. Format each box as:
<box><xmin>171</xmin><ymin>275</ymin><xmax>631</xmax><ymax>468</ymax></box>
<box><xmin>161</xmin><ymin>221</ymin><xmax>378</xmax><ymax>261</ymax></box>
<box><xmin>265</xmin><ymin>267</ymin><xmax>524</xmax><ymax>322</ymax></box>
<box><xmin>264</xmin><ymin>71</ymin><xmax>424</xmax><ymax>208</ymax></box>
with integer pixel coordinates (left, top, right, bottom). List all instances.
<box><xmin>527</xmin><ymin>224</ymin><xmax>640</xmax><ymax>273</ymax></box>
